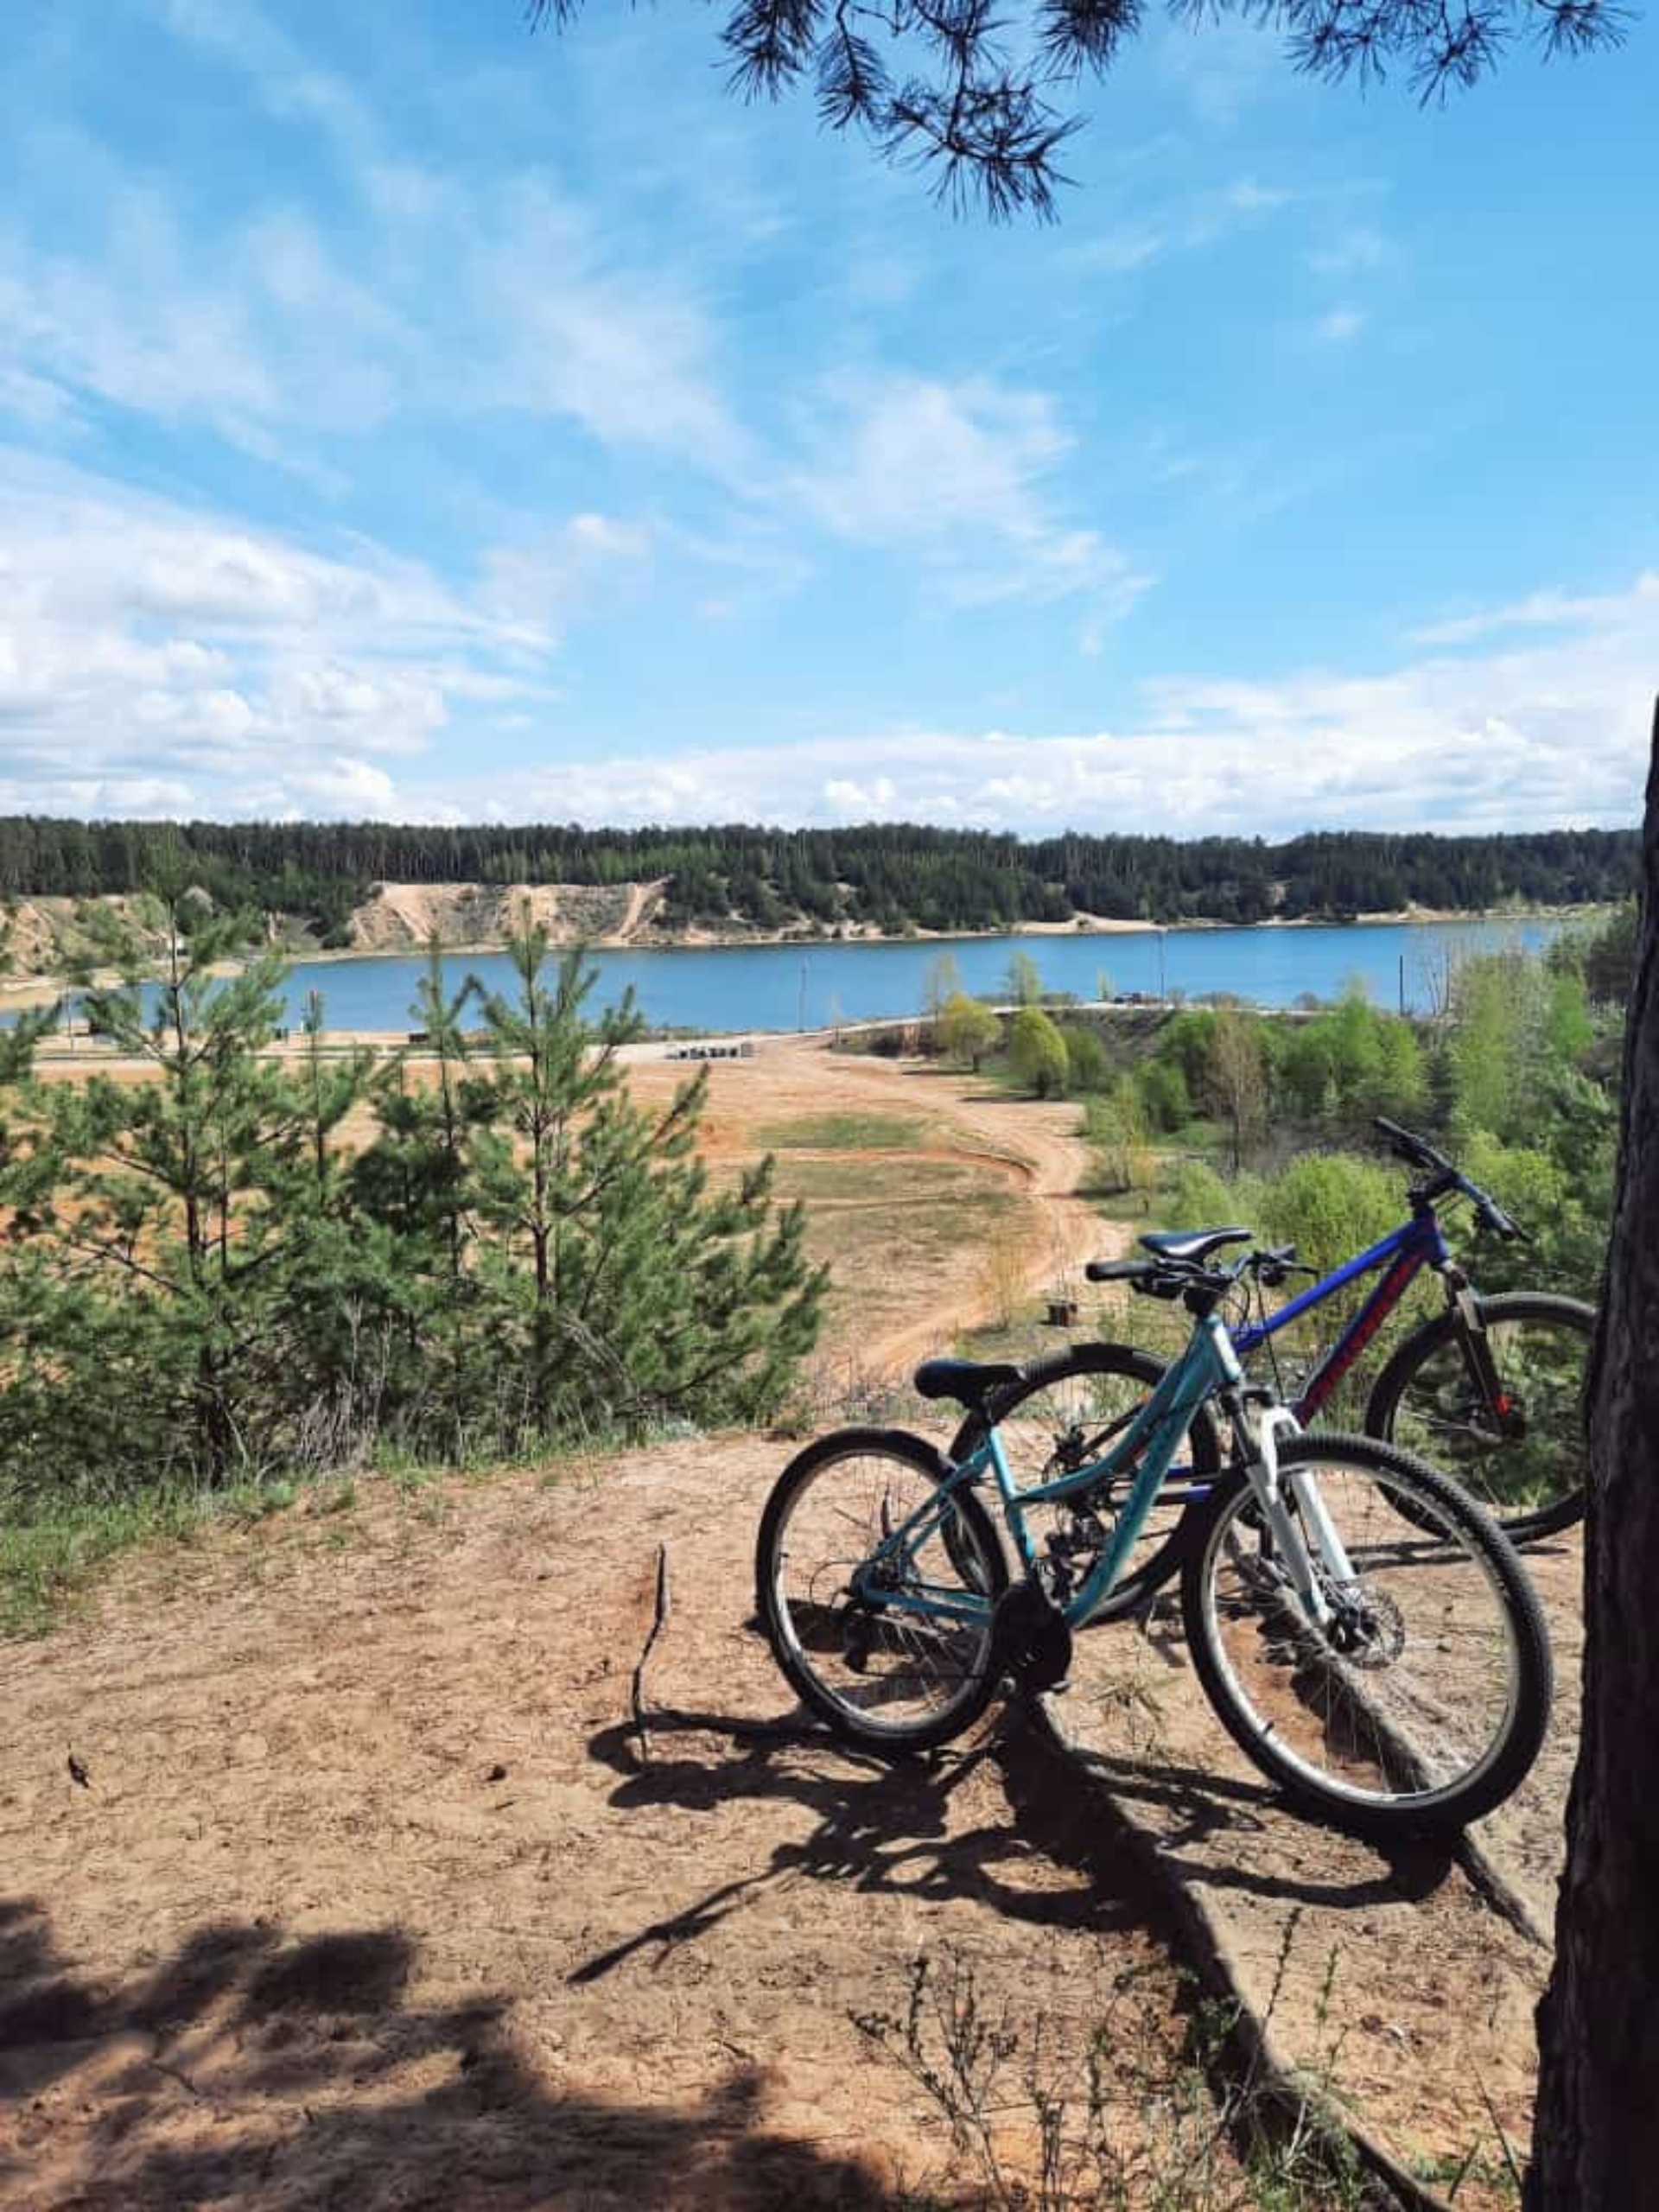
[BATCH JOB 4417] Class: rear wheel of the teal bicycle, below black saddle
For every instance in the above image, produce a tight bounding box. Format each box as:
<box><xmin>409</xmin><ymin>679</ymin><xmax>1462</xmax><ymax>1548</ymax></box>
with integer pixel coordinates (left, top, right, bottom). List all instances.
<box><xmin>754</xmin><ymin>1429</ymin><xmax>1008</xmax><ymax>1752</ymax></box>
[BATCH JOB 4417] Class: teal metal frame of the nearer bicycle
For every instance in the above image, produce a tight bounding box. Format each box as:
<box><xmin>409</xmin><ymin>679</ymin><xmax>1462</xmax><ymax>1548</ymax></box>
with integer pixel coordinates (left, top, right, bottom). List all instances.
<box><xmin>852</xmin><ymin>1314</ymin><xmax>1243</xmax><ymax>1628</ymax></box>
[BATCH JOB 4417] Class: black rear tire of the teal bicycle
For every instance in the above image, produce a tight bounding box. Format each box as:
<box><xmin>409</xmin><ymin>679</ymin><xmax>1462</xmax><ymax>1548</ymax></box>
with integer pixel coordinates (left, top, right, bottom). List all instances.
<box><xmin>754</xmin><ymin>1429</ymin><xmax>1008</xmax><ymax>1754</ymax></box>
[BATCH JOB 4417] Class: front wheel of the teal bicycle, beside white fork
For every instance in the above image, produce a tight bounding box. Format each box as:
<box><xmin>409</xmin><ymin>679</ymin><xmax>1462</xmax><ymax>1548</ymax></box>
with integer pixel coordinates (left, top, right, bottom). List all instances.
<box><xmin>1181</xmin><ymin>1433</ymin><xmax>1551</xmax><ymax>1840</ymax></box>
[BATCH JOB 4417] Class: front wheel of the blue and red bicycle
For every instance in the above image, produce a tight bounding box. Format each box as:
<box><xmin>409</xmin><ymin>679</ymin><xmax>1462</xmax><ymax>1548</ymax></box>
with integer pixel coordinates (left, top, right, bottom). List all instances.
<box><xmin>1365</xmin><ymin>1289</ymin><xmax>1595</xmax><ymax>1541</ymax></box>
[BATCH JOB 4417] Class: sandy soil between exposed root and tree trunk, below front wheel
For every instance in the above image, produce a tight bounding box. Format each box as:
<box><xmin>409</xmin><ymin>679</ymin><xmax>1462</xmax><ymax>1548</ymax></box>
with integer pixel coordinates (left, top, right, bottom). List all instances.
<box><xmin>1048</xmin><ymin>1533</ymin><xmax>1584</xmax><ymax>2208</ymax></box>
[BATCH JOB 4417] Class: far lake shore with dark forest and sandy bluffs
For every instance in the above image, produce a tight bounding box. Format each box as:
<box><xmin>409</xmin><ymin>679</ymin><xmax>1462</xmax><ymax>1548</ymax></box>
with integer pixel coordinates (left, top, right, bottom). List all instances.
<box><xmin>0</xmin><ymin>817</ymin><xmax>1639</xmax><ymax>1008</ymax></box>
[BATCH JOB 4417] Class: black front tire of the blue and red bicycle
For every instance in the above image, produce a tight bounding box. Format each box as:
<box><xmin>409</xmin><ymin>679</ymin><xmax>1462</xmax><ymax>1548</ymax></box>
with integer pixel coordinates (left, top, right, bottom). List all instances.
<box><xmin>1365</xmin><ymin>1289</ymin><xmax>1595</xmax><ymax>1544</ymax></box>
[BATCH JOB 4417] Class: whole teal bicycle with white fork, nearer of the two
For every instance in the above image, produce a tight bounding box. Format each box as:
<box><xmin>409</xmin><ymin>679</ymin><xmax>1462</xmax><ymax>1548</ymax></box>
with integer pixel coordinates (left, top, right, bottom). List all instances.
<box><xmin>757</xmin><ymin>1255</ymin><xmax>1551</xmax><ymax>1840</ymax></box>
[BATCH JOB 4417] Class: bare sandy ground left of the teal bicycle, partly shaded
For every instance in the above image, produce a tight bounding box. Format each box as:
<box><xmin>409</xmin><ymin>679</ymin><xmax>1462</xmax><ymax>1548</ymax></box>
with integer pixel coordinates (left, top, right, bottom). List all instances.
<box><xmin>0</xmin><ymin>1438</ymin><xmax>1177</xmax><ymax>2212</ymax></box>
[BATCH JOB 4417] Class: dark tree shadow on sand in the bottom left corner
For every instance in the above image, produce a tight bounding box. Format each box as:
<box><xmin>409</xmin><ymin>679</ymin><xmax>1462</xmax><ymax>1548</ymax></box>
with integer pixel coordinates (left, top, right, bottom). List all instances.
<box><xmin>0</xmin><ymin>1897</ymin><xmax>889</xmax><ymax>2212</ymax></box>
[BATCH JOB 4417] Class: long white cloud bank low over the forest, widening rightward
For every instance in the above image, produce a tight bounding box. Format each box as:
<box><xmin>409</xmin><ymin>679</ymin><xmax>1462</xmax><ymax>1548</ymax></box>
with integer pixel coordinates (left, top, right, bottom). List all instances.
<box><xmin>382</xmin><ymin>577</ymin><xmax>1659</xmax><ymax>836</ymax></box>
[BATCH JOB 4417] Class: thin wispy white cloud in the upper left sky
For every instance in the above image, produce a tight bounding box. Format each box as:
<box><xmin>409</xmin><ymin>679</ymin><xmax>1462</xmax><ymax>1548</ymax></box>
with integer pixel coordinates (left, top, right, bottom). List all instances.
<box><xmin>0</xmin><ymin>118</ymin><xmax>752</xmax><ymax>482</ymax></box>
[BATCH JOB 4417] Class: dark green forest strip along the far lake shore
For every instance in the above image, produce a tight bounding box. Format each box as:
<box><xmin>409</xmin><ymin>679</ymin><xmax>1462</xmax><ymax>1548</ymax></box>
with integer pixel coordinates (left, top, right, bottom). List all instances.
<box><xmin>0</xmin><ymin>817</ymin><xmax>1639</xmax><ymax>943</ymax></box>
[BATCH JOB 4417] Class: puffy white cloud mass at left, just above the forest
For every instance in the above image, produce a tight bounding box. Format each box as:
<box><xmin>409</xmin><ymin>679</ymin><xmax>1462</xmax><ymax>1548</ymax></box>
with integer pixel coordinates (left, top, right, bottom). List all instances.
<box><xmin>0</xmin><ymin>449</ymin><xmax>562</xmax><ymax>814</ymax></box>
